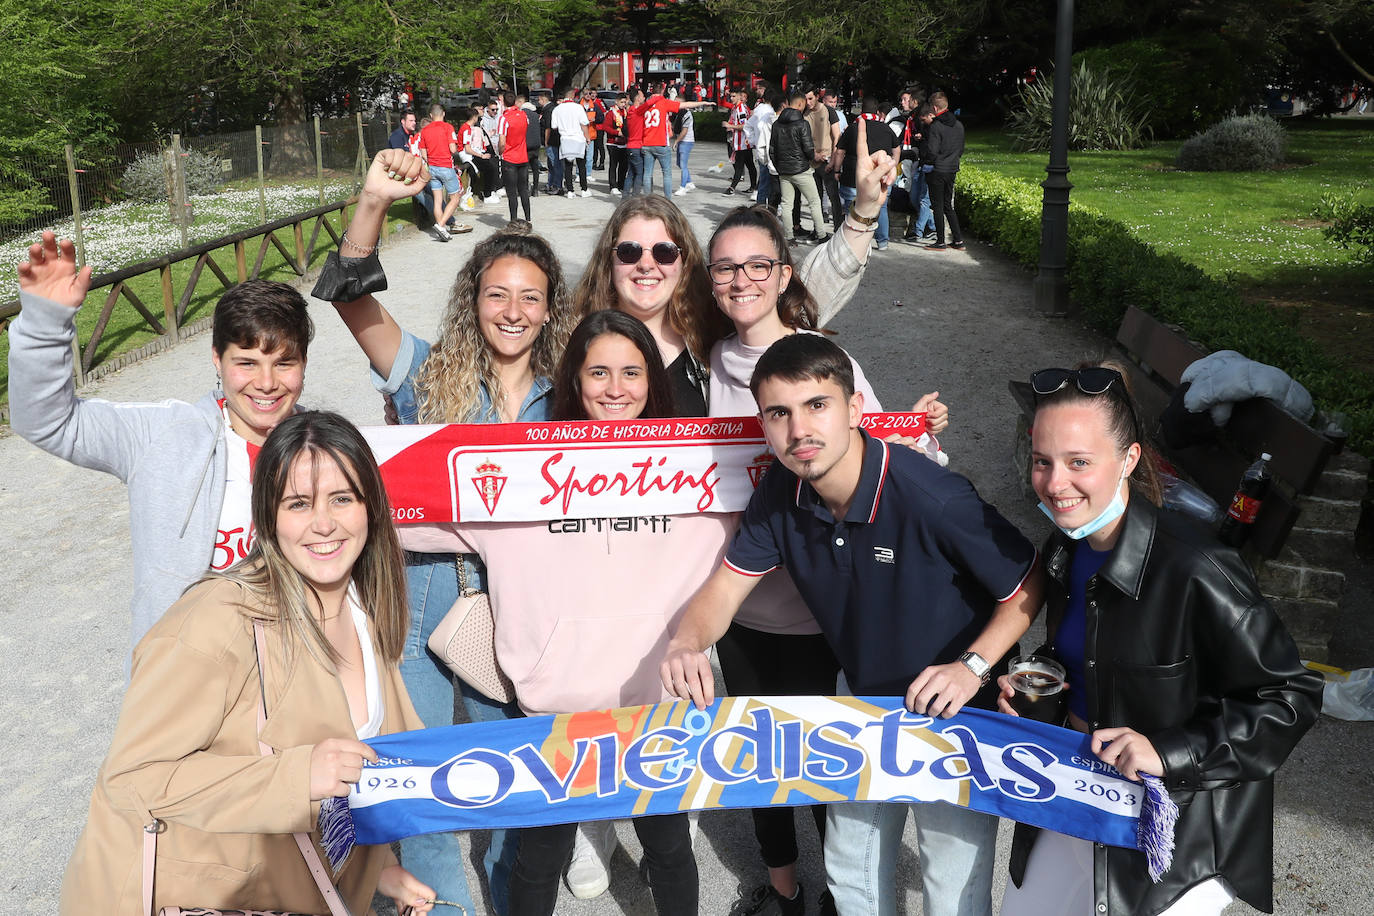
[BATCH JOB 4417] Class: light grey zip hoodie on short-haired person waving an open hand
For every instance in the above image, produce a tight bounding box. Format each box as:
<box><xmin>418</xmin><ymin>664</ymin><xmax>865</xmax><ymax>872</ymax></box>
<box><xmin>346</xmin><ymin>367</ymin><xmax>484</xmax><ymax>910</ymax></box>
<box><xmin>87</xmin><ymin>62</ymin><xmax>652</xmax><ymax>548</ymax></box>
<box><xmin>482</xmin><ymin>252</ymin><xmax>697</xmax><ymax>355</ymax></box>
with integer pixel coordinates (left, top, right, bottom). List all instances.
<box><xmin>10</xmin><ymin>293</ymin><xmax>227</xmax><ymax>650</ymax></box>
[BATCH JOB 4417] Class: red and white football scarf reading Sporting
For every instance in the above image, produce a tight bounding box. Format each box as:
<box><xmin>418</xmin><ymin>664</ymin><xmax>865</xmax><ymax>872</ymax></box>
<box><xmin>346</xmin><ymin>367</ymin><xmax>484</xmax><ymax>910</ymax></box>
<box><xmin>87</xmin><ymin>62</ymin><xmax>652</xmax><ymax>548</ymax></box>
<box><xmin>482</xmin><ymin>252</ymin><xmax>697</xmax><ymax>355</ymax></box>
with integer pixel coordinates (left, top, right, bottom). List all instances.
<box><xmin>363</xmin><ymin>413</ymin><xmax>926</xmax><ymax>525</ymax></box>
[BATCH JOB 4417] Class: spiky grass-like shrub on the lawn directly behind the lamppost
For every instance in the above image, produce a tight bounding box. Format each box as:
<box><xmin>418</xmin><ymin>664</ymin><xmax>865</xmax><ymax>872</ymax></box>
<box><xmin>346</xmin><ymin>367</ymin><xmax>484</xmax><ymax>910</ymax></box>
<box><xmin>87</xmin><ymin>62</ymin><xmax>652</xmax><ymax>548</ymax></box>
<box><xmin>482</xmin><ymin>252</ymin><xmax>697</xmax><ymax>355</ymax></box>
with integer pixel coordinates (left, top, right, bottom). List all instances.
<box><xmin>1007</xmin><ymin>63</ymin><xmax>1149</xmax><ymax>150</ymax></box>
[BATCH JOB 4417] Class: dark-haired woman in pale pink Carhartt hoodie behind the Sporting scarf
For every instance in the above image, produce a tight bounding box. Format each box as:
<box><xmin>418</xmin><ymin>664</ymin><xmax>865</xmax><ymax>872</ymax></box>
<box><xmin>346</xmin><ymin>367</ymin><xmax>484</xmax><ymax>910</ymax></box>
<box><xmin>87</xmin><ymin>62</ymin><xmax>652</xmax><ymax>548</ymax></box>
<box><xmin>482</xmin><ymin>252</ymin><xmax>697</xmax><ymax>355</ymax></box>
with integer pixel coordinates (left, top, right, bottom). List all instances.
<box><xmin>401</xmin><ymin>310</ymin><xmax>735</xmax><ymax>916</ymax></box>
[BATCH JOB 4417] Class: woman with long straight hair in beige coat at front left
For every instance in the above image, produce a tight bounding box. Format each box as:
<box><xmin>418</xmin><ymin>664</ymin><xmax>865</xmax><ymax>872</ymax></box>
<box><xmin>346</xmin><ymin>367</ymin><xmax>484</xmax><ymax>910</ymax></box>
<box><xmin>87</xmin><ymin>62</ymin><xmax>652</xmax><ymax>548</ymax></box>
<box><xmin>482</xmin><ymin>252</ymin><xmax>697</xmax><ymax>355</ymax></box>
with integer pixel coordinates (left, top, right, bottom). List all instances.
<box><xmin>62</xmin><ymin>412</ymin><xmax>433</xmax><ymax>916</ymax></box>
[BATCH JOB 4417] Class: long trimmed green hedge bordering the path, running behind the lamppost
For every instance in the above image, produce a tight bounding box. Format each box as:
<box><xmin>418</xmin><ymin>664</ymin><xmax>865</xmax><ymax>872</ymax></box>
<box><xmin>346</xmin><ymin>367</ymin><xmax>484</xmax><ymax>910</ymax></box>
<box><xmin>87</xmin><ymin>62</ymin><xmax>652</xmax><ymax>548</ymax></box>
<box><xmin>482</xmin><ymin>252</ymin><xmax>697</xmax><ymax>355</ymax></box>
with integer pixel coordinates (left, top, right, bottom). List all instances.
<box><xmin>955</xmin><ymin>165</ymin><xmax>1374</xmax><ymax>455</ymax></box>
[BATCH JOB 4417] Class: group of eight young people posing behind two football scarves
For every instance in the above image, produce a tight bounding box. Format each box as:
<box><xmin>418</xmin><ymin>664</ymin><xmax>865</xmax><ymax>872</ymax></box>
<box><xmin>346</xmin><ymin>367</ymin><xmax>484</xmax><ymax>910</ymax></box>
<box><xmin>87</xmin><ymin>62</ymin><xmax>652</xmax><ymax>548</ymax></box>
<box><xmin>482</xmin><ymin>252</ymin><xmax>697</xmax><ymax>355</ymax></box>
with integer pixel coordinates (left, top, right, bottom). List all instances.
<box><xmin>10</xmin><ymin>103</ymin><xmax>1319</xmax><ymax>916</ymax></box>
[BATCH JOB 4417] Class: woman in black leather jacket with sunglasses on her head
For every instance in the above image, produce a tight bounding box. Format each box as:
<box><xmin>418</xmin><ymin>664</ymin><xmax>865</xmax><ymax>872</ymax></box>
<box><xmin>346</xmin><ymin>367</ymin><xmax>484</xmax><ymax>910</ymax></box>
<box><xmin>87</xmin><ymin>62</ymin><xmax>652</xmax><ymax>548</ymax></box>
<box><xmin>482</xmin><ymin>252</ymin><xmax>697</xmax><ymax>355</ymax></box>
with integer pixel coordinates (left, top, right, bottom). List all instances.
<box><xmin>999</xmin><ymin>365</ymin><xmax>1322</xmax><ymax>916</ymax></box>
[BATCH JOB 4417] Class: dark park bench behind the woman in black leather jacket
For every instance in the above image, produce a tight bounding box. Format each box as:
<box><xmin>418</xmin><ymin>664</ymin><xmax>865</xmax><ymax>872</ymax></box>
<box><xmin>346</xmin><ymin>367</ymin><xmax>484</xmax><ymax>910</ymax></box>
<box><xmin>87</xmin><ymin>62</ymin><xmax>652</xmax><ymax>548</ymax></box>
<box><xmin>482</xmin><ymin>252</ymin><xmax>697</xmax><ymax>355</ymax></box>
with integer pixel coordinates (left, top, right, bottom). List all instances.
<box><xmin>1009</xmin><ymin>306</ymin><xmax>1369</xmax><ymax>661</ymax></box>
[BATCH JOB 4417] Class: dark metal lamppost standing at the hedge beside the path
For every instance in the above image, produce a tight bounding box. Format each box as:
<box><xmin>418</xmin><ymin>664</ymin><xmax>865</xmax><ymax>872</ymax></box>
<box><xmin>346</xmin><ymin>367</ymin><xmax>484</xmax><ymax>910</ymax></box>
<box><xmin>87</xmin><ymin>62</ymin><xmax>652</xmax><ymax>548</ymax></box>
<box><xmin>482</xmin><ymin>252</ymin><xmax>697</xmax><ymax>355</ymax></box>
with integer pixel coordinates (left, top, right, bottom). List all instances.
<box><xmin>1035</xmin><ymin>0</ymin><xmax>1073</xmax><ymax>314</ymax></box>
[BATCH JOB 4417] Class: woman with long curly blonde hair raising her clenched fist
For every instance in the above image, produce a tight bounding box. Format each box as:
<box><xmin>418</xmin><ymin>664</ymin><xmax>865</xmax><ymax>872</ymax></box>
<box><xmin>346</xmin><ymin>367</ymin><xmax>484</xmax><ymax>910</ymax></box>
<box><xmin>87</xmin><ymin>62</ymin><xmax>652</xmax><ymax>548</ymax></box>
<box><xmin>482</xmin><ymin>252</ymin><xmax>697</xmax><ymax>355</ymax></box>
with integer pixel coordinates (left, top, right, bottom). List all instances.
<box><xmin>315</xmin><ymin>150</ymin><xmax>576</xmax><ymax>913</ymax></box>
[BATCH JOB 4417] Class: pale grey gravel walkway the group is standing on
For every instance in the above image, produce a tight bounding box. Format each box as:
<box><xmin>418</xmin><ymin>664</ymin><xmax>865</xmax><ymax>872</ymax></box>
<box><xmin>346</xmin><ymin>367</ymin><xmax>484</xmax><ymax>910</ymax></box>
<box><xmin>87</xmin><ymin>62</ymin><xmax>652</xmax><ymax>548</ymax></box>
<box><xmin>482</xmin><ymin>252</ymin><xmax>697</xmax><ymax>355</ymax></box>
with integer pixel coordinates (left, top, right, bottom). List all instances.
<box><xmin>0</xmin><ymin>144</ymin><xmax>1374</xmax><ymax>916</ymax></box>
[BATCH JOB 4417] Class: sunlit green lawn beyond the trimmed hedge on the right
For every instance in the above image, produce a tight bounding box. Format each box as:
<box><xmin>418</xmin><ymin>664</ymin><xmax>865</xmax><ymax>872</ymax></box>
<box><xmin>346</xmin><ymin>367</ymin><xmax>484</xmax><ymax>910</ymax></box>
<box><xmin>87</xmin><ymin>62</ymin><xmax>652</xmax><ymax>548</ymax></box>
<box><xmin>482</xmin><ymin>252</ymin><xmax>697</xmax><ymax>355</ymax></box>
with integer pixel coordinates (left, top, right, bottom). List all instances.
<box><xmin>965</xmin><ymin>119</ymin><xmax>1374</xmax><ymax>284</ymax></box>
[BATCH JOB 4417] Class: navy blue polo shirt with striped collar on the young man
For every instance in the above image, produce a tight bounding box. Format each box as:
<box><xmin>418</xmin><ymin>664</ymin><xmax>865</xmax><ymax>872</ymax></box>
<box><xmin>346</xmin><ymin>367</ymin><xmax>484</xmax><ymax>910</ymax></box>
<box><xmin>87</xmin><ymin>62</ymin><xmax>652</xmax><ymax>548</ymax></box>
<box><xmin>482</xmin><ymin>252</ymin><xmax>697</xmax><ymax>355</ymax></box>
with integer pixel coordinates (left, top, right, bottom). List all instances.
<box><xmin>725</xmin><ymin>430</ymin><xmax>1036</xmax><ymax>696</ymax></box>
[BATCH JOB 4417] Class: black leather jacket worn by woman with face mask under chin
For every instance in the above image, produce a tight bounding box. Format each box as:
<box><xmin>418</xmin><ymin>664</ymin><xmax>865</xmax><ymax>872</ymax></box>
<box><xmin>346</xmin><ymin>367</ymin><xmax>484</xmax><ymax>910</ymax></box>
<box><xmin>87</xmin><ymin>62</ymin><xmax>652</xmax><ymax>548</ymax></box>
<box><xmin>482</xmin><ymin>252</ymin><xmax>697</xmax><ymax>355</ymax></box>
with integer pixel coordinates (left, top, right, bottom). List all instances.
<box><xmin>1011</xmin><ymin>496</ymin><xmax>1322</xmax><ymax>916</ymax></box>
